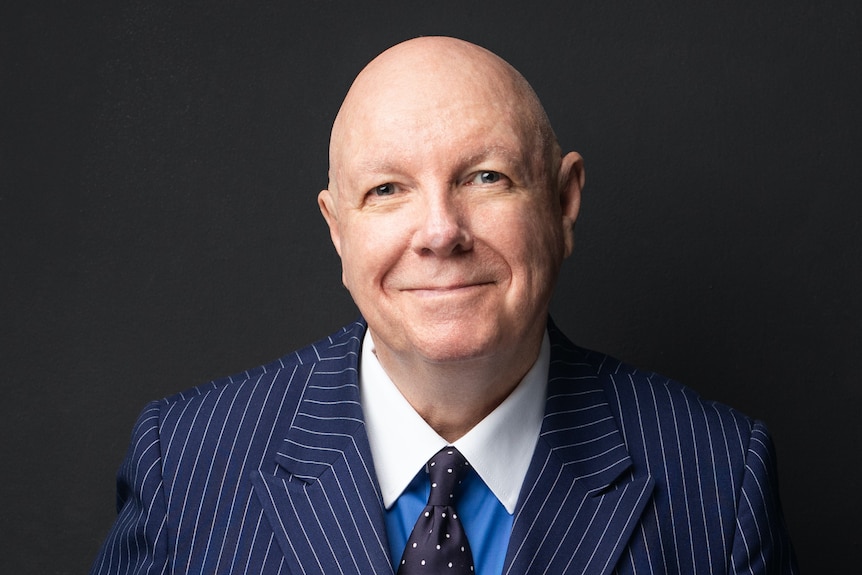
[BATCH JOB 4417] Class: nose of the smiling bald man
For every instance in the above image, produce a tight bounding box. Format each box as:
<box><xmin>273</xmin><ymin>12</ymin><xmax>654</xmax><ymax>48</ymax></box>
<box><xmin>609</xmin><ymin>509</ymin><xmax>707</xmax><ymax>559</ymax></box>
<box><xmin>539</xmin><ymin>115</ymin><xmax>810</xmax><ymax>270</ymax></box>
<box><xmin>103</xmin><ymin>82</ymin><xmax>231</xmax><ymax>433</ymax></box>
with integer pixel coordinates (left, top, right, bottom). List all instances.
<box><xmin>414</xmin><ymin>190</ymin><xmax>473</xmax><ymax>257</ymax></box>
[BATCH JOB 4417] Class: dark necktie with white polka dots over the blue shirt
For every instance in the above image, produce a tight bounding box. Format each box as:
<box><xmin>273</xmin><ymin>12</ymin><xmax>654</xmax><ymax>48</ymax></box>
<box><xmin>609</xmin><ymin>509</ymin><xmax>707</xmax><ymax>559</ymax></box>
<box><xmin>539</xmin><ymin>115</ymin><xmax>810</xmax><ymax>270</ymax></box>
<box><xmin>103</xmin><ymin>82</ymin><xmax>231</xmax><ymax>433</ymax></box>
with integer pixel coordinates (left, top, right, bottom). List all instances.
<box><xmin>398</xmin><ymin>446</ymin><xmax>473</xmax><ymax>575</ymax></box>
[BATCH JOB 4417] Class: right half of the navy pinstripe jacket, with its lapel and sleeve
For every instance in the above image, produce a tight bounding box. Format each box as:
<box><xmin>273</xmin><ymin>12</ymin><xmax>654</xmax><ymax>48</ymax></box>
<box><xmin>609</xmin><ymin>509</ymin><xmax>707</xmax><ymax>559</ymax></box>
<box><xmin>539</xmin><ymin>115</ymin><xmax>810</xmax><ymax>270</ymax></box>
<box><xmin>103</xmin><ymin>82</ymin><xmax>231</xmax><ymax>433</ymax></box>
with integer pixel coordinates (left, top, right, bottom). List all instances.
<box><xmin>506</xmin><ymin>324</ymin><xmax>798</xmax><ymax>575</ymax></box>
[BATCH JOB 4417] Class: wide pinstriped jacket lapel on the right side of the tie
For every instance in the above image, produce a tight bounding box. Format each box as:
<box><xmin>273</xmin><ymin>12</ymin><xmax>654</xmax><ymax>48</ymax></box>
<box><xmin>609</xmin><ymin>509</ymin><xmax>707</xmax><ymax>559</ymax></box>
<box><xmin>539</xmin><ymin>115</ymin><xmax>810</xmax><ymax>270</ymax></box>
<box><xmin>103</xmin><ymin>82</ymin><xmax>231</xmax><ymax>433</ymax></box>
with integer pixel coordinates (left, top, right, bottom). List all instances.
<box><xmin>503</xmin><ymin>324</ymin><xmax>654</xmax><ymax>575</ymax></box>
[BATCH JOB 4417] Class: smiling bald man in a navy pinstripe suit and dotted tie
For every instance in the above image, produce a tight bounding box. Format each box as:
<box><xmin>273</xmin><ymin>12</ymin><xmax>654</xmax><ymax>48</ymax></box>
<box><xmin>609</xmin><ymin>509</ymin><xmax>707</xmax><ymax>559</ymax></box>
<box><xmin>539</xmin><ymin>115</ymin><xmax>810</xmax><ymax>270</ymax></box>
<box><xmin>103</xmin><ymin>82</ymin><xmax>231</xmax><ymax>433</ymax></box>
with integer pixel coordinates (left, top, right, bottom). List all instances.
<box><xmin>92</xmin><ymin>38</ymin><xmax>796</xmax><ymax>575</ymax></box>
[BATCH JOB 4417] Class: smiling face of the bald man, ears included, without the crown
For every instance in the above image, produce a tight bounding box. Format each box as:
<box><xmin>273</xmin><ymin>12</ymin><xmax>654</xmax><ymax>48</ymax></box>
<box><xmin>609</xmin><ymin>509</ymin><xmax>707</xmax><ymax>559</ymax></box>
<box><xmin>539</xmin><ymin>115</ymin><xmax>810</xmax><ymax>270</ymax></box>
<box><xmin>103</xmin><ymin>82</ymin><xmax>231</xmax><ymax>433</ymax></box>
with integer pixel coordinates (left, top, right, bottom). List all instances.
<box><xmin>319</xmin><ymin>47</ymin><xmax>581</xmax><ymax>368</ymax></box>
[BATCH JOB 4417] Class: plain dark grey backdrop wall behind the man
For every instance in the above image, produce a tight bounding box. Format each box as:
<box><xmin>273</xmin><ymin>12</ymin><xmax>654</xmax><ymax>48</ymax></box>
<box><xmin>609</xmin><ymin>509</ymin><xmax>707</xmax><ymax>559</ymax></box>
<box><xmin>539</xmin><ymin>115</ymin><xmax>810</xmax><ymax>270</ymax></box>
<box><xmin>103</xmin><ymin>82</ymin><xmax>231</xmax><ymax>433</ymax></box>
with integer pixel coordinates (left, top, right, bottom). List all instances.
<box><xmin>0</xmin><ymin>0</ymin><xmax>862</xmax><ymax>574</ymax></box>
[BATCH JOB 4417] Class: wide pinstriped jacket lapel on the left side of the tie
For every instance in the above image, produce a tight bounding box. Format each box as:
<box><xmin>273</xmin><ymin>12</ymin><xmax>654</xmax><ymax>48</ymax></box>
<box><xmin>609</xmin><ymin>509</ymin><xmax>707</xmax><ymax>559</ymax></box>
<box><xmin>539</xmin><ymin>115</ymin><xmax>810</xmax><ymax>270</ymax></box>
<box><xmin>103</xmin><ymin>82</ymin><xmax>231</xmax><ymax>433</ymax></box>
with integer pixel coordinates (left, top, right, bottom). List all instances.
<box><xmin>252</xmin><ymin>324</ymin><xmax>392</xmax><ymax>575</ymax></box>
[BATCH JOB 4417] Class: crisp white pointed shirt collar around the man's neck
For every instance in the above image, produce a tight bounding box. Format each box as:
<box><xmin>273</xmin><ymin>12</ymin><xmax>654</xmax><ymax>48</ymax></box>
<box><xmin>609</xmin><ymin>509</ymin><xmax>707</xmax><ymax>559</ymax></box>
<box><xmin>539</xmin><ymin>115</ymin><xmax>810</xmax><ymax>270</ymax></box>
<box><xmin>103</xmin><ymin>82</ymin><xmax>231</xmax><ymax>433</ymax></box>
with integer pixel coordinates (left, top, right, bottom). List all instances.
<box><xmin>359</xmin><ymin>330</ymin><xmax>551</xmax><ymax>514</ymax></box>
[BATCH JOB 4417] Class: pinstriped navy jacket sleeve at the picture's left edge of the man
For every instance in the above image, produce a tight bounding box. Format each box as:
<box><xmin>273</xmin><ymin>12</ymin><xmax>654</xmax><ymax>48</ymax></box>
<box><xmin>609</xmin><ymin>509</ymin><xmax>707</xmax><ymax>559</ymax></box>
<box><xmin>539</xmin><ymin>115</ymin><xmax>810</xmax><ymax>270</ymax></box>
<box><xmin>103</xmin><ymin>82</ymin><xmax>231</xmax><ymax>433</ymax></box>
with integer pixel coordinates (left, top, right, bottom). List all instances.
<box><xmin>90</xmin><ymin>402</ymin><xmax>168</xmax><ymax>575</ymax></box>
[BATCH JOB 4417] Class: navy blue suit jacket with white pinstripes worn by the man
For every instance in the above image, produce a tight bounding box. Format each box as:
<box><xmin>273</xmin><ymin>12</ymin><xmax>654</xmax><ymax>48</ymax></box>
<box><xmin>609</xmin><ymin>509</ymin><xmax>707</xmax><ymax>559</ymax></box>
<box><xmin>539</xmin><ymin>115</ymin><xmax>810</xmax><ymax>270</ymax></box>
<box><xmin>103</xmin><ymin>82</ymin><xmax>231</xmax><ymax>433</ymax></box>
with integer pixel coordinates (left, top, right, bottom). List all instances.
<box><xmin>92</xmin><ymin>322</ymin><xmax>796</xmax><ymax>575</ymax></box>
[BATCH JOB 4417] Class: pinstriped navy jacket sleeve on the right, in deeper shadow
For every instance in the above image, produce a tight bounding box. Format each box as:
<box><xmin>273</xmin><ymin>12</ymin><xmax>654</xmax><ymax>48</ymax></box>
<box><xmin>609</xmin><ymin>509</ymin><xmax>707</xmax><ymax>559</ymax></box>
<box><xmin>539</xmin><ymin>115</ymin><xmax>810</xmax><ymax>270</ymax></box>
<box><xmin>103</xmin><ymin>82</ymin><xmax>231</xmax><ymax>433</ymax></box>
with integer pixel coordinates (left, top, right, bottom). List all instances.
<box><xmin>731</xmin><ymin>422</ymin><xmax>799</xmax><ymax>575</ymax></box>
